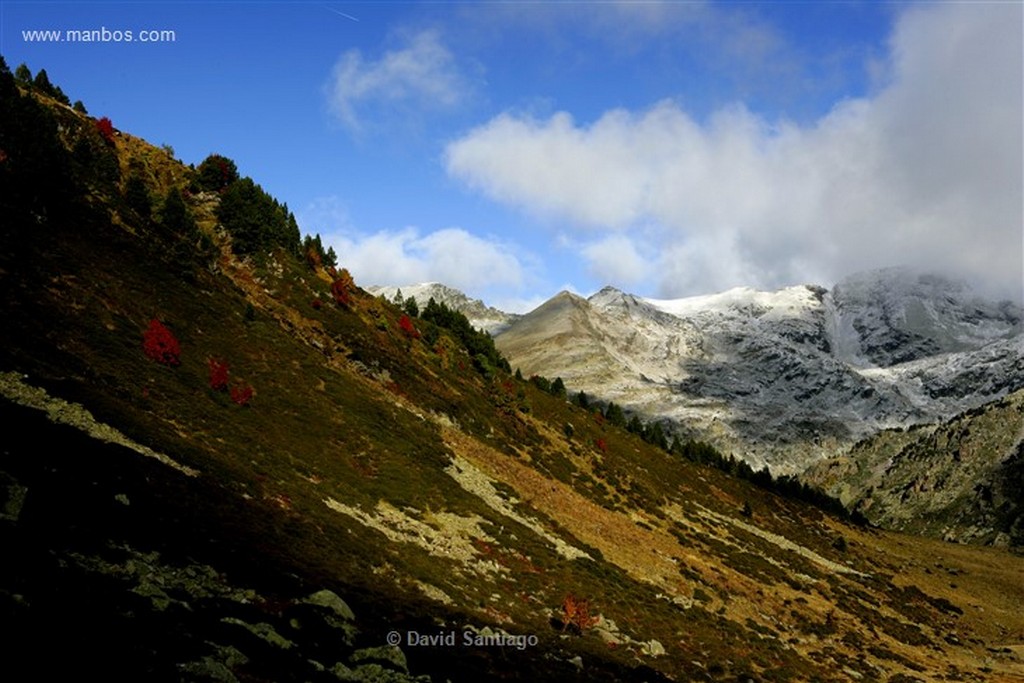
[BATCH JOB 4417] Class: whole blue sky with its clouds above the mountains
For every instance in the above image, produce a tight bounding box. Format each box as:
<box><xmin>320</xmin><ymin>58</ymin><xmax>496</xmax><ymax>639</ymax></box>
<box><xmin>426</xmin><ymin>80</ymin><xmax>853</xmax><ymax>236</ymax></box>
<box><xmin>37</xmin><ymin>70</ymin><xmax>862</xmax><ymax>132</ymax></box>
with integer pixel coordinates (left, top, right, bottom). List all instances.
<box><xmin>0</xmin><ymin>2</ymin><xmax>1024</xmax><ymax>310</ymax></box>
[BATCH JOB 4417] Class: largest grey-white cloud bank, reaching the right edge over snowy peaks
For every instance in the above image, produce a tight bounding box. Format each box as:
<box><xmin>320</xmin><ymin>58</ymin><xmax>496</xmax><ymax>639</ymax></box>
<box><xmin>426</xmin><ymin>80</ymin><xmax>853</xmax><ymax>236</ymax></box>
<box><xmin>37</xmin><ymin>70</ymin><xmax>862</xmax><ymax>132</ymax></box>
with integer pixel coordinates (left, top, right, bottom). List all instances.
<box><xmin>445</xmin><ymin>3</ymin><xmax>1024</xmax><ymax>296</ymax></box>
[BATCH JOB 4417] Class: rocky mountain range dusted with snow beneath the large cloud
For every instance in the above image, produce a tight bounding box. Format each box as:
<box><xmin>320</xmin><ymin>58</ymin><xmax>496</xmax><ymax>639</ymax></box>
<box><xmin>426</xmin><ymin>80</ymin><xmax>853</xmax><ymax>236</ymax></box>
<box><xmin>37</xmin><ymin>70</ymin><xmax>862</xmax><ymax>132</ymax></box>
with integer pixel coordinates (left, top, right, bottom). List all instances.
<box><xmin>496</xmin><ymin>268</ymin><xmax>1024</xmax><ymax>473</ymax></box>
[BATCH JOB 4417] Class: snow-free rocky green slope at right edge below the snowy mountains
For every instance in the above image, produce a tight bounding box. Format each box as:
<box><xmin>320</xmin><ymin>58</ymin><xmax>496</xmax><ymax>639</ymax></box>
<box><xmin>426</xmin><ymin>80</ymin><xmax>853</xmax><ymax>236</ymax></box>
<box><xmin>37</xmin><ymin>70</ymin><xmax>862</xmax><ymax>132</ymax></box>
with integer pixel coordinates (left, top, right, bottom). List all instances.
<box><xmin>802</xmin><ymin>391</ymin><xmax>1024</xmax><ymax>545</ymax></box>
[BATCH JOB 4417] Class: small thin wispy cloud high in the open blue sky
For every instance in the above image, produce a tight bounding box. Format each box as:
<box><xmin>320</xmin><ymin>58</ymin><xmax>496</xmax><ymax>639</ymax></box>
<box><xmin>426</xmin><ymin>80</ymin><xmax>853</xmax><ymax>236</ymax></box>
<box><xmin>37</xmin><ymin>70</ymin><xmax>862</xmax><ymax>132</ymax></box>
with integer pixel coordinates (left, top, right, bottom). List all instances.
<box><xmin>328</xmin><ymin>31</ymin><xmax>468</xmax><ymax>131</ymax></box>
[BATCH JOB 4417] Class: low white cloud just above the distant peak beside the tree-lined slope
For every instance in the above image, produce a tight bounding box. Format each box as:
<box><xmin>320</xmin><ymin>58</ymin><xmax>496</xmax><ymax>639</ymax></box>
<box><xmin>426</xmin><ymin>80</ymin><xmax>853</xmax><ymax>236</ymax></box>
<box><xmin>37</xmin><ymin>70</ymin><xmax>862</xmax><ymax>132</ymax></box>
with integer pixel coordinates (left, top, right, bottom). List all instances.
<box><xmin>323</xmin><ymin>227</ymin><xmax>526</xmax><ymax>292</ymax></box>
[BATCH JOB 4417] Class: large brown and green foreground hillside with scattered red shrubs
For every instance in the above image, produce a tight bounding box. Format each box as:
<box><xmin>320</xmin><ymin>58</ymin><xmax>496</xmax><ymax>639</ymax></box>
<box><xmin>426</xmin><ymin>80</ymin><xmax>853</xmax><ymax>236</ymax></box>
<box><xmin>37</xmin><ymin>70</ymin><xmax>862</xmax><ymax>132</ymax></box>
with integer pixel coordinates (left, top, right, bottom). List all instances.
<box><xmin>0</xmin><ymin>60</ymin><xmax>1024</xmax><ymax>681</ymax></box>
